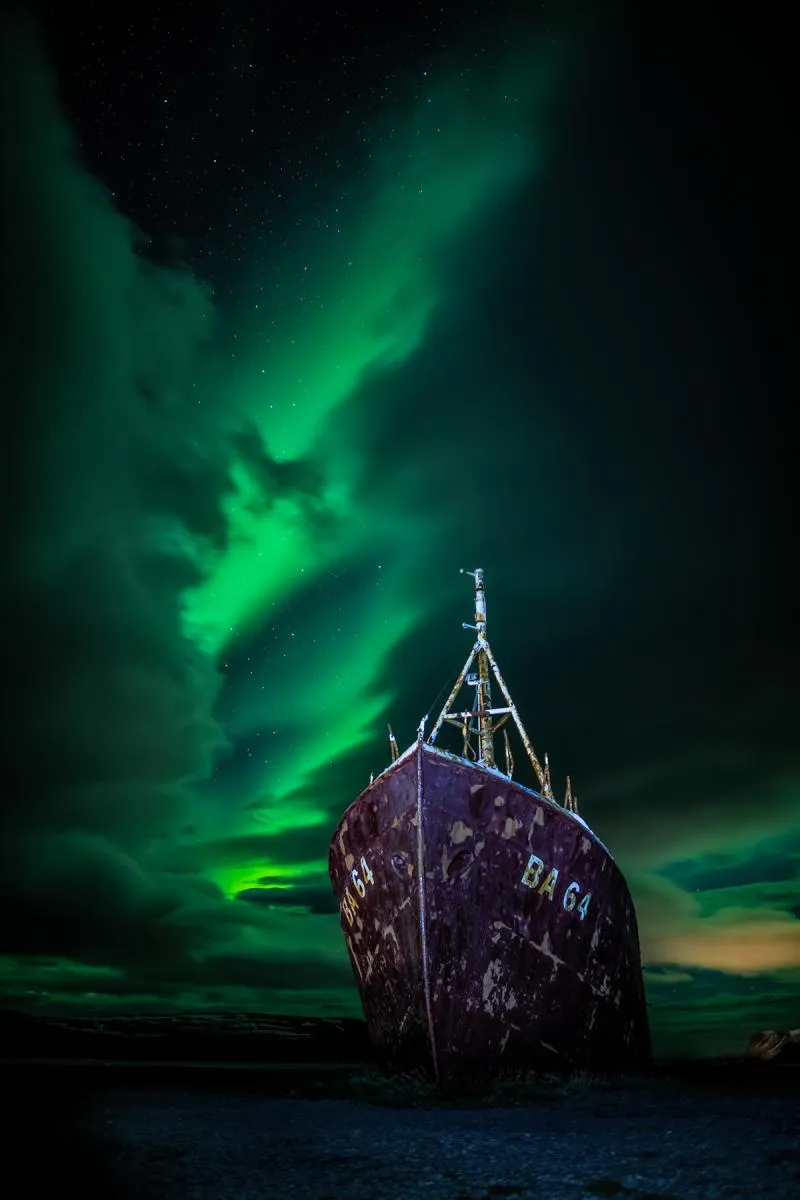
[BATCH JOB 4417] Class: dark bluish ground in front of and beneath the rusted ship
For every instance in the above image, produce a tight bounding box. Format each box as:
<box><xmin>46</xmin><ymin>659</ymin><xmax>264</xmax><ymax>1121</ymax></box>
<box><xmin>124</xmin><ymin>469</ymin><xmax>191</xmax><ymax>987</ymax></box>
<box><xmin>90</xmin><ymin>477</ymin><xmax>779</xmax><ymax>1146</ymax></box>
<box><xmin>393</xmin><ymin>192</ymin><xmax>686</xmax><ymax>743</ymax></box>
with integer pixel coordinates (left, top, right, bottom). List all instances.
<box><xmin>4</xmin><ymin>1067</ymin><xmax>800</xmax><ymax>1200</ymax></box>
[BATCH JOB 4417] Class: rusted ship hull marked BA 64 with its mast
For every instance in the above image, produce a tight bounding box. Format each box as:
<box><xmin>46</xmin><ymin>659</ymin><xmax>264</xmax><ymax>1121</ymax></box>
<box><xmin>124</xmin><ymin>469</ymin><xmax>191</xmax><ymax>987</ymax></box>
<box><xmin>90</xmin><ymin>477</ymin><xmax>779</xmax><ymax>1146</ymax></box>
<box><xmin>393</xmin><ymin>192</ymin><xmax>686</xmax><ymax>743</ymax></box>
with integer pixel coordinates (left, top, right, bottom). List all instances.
<box><xmin>330</xmin><ymin>570</ymin><xmax>650</xmax><ymax>1086</ymax></box>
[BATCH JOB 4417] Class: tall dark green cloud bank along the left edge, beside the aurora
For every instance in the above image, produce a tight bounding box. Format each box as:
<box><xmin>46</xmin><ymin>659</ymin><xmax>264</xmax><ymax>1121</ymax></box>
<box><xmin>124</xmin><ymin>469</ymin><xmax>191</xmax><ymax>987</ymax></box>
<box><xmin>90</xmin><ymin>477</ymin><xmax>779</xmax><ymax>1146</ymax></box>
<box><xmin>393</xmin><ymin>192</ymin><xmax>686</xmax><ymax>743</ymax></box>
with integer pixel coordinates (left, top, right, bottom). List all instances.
<box><xmin>0</xmin><ymin>16</ymin><xmax>241</xmax><ymax>984</ymax></box>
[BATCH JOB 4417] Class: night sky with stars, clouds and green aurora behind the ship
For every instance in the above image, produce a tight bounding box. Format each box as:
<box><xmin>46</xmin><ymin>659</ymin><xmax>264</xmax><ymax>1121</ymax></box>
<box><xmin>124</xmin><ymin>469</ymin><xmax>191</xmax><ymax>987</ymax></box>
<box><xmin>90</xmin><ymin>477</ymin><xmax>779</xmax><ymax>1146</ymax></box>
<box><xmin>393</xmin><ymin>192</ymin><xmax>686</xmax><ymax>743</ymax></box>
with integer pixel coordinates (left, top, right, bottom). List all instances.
<box><xmin>0</xmin><ymin>0</ymin><xmax>800</xmax><ymax>1055</ymax></box>
